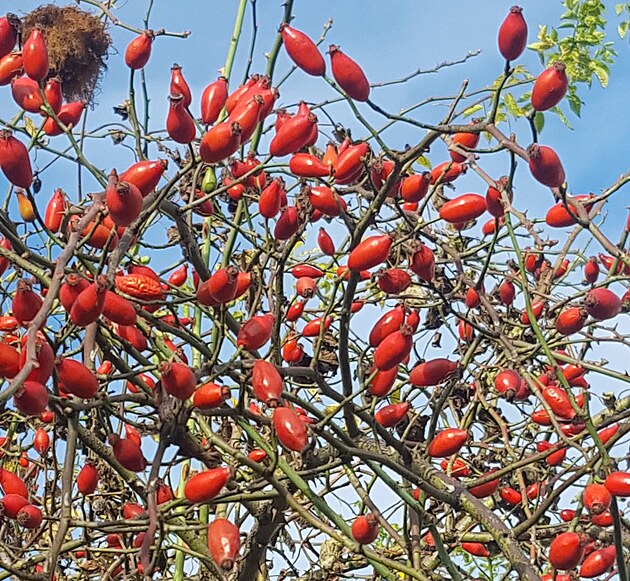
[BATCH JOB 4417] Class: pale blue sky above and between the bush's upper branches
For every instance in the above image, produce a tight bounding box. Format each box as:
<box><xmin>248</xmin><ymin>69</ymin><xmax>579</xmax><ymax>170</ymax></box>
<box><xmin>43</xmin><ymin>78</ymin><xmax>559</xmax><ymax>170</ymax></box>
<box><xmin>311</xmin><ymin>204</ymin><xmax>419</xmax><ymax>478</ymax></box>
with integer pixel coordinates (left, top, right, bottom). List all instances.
<box><xmin>9</xmin><ymin>0</ymin><xmax>630</xmax><ymax>236</ymax></box>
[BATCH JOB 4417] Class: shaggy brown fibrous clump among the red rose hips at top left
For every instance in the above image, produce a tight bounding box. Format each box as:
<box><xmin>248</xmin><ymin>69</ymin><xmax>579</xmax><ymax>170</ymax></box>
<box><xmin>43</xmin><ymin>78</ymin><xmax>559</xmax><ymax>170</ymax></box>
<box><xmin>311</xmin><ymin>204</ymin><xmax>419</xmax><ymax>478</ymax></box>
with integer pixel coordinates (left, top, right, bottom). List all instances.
<box><xmin>22</xmin><ymin>4</ymin><xmax>112</xmax><ymax>103</ymax></box>
